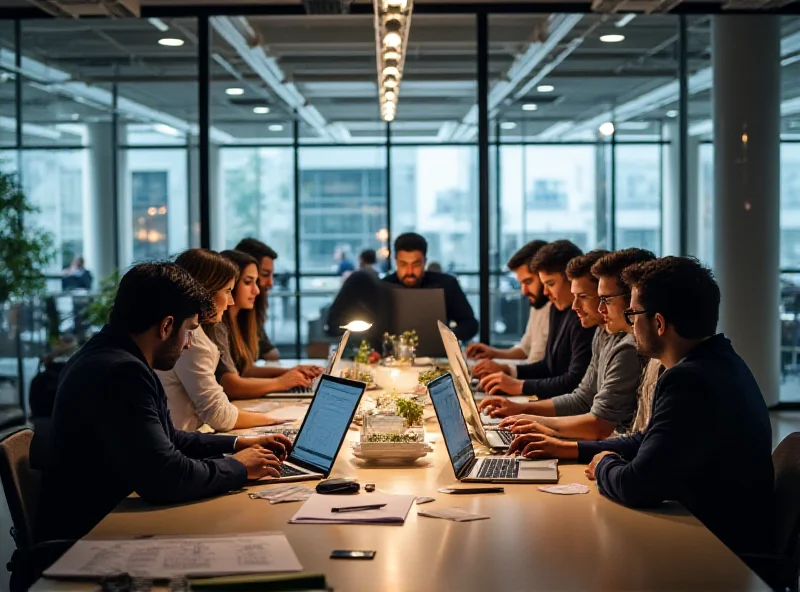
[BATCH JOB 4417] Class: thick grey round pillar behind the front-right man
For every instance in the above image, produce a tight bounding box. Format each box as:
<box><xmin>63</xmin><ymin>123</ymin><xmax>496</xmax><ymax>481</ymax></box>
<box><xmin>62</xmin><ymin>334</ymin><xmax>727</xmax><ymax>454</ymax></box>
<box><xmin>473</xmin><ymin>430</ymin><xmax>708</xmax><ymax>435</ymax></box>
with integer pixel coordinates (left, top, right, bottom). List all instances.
<box><xmin>712</xmin><ymin>15</ymin><xmax>781</xmax><ymax>405</ymax></box>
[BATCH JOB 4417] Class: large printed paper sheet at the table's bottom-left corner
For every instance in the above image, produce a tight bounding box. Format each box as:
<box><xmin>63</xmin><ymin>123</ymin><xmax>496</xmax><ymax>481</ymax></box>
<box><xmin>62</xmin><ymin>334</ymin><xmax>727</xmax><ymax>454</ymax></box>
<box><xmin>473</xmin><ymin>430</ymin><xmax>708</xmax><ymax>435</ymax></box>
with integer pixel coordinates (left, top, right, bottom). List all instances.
<box><xmin>44</xmin><ymin>532</ymin><xmax>303</xmax><ymax>579</ymax></box>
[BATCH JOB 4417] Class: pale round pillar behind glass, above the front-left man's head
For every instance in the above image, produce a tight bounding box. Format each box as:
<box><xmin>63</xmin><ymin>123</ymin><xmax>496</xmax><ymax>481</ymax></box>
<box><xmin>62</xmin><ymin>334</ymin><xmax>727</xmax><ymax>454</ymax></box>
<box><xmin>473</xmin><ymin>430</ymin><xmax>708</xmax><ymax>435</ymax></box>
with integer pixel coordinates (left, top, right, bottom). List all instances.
<box><xmin>83</xmin><ymin>123</ymin><xmax>125</xmax><ymax>281</ymax></box>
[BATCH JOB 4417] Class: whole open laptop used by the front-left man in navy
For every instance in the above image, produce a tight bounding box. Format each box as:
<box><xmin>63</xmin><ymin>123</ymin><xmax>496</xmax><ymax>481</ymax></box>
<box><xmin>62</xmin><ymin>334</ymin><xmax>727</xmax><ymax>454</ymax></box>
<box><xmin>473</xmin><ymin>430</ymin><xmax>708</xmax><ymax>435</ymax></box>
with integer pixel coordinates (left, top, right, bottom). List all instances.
<box><xmin>269</xmin><ymin>375</ymin><xmax>367</xmax><ymax>483</ymax></box>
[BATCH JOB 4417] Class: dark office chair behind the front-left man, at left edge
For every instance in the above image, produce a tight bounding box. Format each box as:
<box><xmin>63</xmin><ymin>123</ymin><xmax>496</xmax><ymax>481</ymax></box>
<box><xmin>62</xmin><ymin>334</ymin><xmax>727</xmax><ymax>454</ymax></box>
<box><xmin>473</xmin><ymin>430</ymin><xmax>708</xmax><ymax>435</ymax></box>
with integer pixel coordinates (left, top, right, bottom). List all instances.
<box><xmin>0</xmin><ymin>428</ymin><xmax>75</xmax><ymax>592</ymax></box>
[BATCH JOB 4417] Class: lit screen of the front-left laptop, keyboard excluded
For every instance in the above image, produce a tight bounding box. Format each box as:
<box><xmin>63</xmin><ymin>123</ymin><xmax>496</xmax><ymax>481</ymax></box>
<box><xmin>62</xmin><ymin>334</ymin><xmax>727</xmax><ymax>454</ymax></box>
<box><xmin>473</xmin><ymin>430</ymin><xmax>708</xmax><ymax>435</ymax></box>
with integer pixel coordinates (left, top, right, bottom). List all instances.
<box><xmin>289</xmin><ymin>375</ymin><xmax>364</xmax><ymax>474</ymax></box>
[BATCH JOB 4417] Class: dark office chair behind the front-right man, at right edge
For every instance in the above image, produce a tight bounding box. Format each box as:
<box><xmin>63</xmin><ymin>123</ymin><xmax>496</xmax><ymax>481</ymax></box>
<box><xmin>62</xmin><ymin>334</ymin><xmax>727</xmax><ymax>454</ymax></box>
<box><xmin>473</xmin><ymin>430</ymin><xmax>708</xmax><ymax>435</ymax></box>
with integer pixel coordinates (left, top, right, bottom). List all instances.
<box><xmin>742</xmin><ymin>432</ymin><xmax>800</xmax><ymax>592</ymax></box>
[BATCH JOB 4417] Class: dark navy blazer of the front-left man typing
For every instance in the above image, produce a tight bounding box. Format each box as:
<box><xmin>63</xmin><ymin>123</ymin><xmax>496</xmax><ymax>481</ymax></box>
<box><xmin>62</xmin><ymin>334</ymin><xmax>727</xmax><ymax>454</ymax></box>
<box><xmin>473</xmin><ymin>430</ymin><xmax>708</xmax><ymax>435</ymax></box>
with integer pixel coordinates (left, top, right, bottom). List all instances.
<box><xmin>34</xmin><ymin>326</ymin><xmax>247</xmax><ymax>541</ymax></box>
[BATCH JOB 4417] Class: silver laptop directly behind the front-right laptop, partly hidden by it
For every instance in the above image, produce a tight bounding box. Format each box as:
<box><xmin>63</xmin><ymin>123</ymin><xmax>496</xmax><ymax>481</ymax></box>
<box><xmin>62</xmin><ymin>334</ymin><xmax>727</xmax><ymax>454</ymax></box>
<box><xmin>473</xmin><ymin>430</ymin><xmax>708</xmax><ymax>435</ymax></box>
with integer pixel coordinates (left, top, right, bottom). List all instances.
<box><xmin>439</xmin><ymin>323</ymin><xmax>514</xmax><ymax>450</ymax></box>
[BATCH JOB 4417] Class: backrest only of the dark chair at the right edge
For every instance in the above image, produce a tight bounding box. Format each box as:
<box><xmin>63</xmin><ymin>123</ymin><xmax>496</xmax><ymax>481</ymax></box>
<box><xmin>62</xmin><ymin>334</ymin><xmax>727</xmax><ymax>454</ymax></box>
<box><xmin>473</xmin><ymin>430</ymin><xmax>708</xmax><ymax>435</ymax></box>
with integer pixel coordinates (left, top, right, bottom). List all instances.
<box><xmin>772</xmin><ymin>432</ymin><xmax>800</xmax><ymax>557</ymax></box>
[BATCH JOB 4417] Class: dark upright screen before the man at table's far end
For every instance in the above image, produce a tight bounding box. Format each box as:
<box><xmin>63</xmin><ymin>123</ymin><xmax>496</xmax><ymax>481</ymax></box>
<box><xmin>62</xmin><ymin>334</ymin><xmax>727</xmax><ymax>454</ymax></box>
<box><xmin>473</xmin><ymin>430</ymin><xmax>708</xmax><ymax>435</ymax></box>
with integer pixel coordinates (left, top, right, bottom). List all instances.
<box><xmin>389</xmin><ymin>288</ymin><xmax>447</xmax><ymax>358</ymax></box>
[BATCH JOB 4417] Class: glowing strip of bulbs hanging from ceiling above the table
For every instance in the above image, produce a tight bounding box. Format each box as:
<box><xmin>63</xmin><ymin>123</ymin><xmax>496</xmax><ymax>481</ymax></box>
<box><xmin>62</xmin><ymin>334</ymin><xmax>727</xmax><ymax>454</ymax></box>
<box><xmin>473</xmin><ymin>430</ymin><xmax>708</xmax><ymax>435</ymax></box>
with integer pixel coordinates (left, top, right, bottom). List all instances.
<box><xmin>372</xmin><ymin>0</ymin><xmax>414</xmax><ymax>121</ymax></box>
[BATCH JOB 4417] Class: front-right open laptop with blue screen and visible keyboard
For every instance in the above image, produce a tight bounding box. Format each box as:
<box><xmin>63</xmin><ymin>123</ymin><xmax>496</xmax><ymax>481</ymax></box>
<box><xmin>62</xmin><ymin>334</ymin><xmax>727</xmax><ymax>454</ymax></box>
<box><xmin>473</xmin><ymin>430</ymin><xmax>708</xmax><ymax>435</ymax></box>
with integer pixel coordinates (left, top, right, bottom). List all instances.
<box><xmin>428</xmin><ymin>374</ymin><xmax>558</xmax><ymax>483</ymax></box>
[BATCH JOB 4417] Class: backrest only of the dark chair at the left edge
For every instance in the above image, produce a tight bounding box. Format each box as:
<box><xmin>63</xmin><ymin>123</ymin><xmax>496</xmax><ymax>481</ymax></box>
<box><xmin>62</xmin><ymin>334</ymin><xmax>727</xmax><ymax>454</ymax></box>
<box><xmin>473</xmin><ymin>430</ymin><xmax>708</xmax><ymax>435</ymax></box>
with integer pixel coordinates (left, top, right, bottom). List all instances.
<box><xmin>0</xmin><ymin>428</ymin><xmax>41</xmax><ymax>550</ymax></box>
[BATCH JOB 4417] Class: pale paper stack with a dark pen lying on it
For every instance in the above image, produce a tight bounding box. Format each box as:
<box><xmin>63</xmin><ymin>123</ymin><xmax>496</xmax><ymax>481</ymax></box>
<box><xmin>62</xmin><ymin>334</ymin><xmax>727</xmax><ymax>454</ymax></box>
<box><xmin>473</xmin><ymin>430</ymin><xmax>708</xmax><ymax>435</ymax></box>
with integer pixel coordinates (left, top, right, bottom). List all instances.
<box><xmin>289</xmin><ymin>492</ymin><xmax>416</xmax><ymax>524</ymax></box>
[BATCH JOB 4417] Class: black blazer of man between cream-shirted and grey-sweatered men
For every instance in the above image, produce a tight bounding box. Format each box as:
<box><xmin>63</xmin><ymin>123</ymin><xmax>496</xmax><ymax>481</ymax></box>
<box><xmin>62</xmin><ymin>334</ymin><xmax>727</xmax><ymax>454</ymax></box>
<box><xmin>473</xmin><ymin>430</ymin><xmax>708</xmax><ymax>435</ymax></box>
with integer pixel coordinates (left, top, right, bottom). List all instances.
<box><xmin>517</xmin><ymin>306</ymin><xmax>597</xmax><ymax>399</ymax></box>
